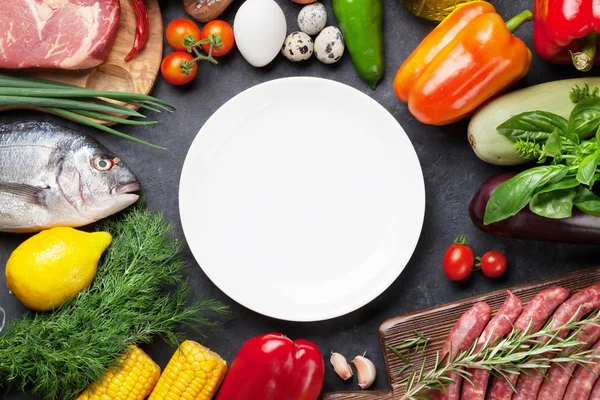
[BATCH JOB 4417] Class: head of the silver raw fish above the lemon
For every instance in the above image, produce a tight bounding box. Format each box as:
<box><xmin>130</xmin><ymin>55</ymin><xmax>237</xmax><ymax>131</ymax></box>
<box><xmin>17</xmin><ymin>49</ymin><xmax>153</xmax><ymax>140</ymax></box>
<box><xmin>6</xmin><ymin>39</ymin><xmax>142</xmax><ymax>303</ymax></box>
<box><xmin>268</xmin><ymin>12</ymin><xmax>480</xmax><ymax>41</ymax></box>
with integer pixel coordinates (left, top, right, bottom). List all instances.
<box><xmin>58</xmin><ymin>137</ymin><xmax>141</xmax><ymax>221</ymax></box>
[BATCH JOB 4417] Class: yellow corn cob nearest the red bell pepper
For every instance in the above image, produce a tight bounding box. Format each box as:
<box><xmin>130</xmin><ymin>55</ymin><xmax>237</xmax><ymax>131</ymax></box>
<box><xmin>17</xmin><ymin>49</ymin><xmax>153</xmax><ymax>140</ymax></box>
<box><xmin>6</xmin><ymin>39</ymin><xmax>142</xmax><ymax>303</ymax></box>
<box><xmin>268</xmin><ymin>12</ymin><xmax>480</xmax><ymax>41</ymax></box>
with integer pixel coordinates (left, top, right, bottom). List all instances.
<box><xmin>148</xmin><ymin>340</ymin><xmax>227</xmax><ymax>400</ymax></box>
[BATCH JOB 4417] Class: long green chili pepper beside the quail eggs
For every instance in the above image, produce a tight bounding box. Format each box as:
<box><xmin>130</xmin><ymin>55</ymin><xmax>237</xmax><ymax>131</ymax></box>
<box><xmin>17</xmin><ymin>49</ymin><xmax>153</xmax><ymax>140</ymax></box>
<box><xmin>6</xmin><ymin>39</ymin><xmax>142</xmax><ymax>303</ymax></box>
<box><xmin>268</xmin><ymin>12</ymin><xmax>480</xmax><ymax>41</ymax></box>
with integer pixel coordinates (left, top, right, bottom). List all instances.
<box><xmin>333</xmin><ymin>0</ymin><xmax>384</xmax><ymax>89</ymax></box>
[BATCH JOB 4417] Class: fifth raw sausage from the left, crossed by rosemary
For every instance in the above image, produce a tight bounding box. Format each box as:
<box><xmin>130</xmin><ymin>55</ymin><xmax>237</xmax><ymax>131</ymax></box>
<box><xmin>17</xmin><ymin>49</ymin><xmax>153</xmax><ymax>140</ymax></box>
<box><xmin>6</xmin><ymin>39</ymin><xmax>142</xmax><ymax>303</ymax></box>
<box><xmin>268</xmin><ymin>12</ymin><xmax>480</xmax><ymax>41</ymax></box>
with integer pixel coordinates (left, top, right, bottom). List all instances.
<box><xmin>537</xmin><ymin>325</ymin><xmax>600</xmax><ymax>400</ymax></box>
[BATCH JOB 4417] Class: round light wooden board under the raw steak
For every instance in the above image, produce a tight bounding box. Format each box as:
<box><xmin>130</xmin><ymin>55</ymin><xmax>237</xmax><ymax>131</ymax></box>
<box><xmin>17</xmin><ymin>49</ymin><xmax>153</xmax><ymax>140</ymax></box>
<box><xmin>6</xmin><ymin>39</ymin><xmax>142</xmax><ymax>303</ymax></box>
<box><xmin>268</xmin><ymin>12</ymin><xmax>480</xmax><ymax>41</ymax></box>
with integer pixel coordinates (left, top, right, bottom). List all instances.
<box><xmin>0</xmin><ymin>0</ymin><xmax>163</xmax><ymax>123</ymax></box>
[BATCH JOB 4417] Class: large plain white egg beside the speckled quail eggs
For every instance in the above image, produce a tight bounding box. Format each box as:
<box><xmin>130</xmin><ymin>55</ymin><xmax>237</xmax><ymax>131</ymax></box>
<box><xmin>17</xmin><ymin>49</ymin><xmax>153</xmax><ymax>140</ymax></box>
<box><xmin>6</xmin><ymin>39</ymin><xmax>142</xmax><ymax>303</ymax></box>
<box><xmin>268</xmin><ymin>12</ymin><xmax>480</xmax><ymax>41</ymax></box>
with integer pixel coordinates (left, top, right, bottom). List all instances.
<box><xmin>233</xmin><ymin>0</ymin><xmax>287</xmax><ymax>67</ymax></box>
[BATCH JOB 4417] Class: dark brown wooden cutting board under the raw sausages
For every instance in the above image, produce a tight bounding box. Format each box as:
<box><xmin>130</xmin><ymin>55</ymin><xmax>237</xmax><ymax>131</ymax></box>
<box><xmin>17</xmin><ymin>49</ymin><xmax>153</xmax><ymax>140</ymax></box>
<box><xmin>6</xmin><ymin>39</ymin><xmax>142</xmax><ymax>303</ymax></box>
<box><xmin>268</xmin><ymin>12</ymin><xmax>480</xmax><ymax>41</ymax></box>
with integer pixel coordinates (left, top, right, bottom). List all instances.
<box><xmin>323</xmin><ymin>267</ymin><xmax>600</xmax><ymax>400</ymax></box>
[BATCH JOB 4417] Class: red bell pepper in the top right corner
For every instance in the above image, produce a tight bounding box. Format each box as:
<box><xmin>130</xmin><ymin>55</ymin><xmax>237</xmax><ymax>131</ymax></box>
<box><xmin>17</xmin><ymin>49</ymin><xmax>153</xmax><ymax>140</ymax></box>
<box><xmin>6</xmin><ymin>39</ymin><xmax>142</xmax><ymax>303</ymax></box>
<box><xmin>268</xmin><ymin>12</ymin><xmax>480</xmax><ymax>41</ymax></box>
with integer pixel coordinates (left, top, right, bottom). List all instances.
<box><xmin>533</xmin><ymin>0</ymin><xmax>600</xmax><ymax>71</ymax></box>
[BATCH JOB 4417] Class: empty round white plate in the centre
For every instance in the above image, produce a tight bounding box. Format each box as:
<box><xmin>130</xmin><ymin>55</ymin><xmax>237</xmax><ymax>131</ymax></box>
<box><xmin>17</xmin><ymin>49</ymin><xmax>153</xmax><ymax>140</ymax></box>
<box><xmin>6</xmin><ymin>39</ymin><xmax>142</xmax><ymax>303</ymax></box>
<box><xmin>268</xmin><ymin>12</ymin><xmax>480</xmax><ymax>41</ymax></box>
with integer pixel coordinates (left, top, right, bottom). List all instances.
<box><xmin>179</xmin><ymin>77</ymin><xmax>425</xmax><ymax>321</ymax></box>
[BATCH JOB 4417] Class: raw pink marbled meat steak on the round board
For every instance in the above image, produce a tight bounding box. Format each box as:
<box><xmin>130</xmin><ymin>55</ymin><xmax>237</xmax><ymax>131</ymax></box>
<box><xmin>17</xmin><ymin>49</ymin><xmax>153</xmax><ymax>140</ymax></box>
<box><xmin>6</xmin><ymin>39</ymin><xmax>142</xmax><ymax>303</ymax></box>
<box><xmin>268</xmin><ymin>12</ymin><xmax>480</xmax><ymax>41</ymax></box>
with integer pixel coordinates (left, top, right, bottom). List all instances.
<box><xmin>0</xmin><ymin>0</ymin><xmax>121</xmax><ymax>69</ymax></box>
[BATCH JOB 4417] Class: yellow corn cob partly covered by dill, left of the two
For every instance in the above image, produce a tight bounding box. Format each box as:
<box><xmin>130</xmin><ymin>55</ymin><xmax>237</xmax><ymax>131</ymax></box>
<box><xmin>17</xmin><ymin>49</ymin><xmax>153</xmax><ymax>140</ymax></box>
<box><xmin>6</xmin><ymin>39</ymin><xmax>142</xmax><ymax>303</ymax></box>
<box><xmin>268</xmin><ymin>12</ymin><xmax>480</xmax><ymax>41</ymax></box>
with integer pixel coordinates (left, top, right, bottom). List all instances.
<box><xmin>77</xmin><ymin>346</ymin><xmax>160</xmax><ymax>400</ymax></box>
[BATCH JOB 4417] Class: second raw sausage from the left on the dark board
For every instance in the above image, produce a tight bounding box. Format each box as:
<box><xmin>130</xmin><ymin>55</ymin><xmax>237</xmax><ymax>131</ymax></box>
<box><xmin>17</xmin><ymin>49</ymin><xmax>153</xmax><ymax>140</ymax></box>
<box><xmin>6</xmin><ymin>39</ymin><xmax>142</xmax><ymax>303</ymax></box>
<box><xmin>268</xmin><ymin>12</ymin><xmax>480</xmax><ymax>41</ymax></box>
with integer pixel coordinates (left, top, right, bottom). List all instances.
<box><xmin>461</xmin><ymin>290</ymin><xmax>523</xmax><ymax>400</ymax></box>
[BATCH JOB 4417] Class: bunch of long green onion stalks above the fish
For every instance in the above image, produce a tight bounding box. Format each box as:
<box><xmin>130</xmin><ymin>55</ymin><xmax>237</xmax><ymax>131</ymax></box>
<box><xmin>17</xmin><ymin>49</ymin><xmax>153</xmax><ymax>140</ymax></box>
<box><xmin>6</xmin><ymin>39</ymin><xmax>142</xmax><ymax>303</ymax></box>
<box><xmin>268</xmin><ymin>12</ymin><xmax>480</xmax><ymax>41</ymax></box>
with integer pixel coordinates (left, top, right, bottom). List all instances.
<box><xmin>0</xmin><ymin>74</ymin><xmax>175</xmax><ymax>149</ymax></box>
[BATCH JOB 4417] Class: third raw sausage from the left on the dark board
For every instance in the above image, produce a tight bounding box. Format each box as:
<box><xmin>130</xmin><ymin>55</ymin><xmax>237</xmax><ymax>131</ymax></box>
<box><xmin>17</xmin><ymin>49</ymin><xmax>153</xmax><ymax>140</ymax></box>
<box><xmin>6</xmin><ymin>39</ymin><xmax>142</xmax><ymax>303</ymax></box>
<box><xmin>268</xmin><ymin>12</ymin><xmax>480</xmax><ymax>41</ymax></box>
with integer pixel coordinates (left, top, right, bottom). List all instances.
<box><xmin>487</xmin><ymin>286</ymin><xmax>569</xmax><ymax>400</ymax></box>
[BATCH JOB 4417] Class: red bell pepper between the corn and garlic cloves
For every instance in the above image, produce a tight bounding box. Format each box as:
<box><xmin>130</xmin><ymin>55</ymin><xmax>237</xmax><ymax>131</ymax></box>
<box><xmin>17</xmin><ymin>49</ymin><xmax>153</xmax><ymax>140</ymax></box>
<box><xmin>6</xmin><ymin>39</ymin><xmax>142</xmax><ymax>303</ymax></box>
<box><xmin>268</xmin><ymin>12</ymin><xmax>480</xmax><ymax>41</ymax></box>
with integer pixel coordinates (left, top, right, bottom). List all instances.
<box><xmin>217</xmin><ymin>333</ymin><xmax>325</xmax><ymax>400</ymax></box>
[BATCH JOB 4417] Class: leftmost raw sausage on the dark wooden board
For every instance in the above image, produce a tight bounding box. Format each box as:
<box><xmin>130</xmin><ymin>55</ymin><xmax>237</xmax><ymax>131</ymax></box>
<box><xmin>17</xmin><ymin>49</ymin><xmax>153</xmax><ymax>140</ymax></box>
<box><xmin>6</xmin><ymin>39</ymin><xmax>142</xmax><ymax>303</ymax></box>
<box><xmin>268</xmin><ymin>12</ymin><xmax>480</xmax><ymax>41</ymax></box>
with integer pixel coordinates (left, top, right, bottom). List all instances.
<box><xmin>433</xmin><ymin>301</ymin><xmax>492</xmax><ymax>400</ymax></box>
